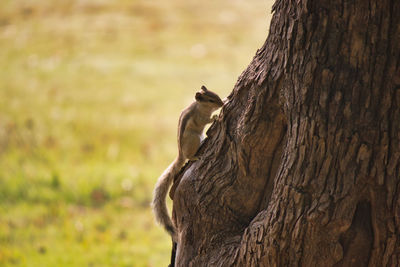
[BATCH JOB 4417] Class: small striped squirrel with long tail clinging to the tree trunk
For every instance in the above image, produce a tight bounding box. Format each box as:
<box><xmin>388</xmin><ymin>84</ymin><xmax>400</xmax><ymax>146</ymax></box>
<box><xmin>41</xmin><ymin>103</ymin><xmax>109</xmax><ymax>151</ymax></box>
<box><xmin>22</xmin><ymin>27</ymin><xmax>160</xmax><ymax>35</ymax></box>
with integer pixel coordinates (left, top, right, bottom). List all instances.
<box><xmin>152</xmin><ymin>85</ymin><xmax>224</xmax><ymax>243</ymax></box>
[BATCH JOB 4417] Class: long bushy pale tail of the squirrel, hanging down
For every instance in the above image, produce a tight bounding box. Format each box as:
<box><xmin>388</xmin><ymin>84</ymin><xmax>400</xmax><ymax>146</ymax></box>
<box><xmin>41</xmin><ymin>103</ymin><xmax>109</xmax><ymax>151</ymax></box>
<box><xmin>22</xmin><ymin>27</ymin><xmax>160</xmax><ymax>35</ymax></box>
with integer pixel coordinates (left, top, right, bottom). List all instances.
<box><xmin>151</xmin><ymin>156</ymin><xmax>185</xmax><ymax>241</ymax></box>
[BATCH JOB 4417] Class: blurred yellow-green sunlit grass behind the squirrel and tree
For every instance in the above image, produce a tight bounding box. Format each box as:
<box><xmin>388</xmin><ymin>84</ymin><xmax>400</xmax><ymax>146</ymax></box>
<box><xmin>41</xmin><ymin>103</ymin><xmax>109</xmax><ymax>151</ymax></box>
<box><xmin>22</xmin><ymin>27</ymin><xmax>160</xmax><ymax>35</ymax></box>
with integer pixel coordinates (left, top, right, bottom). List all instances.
<box><xmin>0</xmin><ymin>0</ymin><xmax>272</xmax><ymax>266</ymax></box>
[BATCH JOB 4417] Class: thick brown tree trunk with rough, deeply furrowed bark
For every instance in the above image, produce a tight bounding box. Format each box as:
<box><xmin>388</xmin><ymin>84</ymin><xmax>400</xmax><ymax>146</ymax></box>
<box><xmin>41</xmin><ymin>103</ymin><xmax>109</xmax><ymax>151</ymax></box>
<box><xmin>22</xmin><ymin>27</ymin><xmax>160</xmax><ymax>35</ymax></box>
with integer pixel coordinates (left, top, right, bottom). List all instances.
<box><xmin>173</xmin><ymin>0</ymin><xmax>400</xmax><ymax>266</ymax></box>
